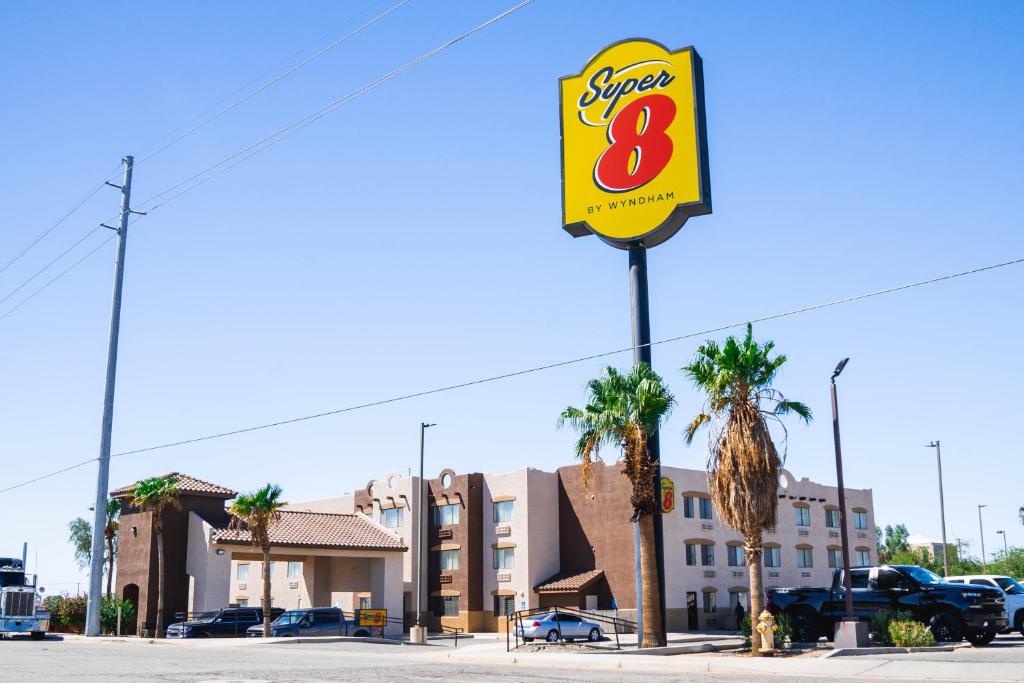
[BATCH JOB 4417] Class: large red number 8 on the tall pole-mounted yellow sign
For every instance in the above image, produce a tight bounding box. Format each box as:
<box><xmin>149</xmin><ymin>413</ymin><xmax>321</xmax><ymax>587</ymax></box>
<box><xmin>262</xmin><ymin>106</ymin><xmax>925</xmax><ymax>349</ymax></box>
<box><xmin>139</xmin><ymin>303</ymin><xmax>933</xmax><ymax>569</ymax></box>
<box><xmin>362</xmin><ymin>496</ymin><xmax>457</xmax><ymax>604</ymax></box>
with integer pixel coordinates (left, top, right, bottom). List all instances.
<box><xmin>594</xmin><ymin>95</ymin><xmax>676</xmax><ymax>193</ymax></box>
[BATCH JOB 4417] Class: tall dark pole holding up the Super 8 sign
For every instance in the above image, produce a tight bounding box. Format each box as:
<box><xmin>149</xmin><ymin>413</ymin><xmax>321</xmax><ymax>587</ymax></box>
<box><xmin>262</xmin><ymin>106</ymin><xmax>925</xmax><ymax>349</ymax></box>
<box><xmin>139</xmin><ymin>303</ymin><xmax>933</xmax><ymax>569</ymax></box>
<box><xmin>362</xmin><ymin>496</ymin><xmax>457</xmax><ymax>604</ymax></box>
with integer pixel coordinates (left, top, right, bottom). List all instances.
<box><xmin>630</xmin><ymin>244</ymin><xmax>667</xmax><ymax>646</ymax></box>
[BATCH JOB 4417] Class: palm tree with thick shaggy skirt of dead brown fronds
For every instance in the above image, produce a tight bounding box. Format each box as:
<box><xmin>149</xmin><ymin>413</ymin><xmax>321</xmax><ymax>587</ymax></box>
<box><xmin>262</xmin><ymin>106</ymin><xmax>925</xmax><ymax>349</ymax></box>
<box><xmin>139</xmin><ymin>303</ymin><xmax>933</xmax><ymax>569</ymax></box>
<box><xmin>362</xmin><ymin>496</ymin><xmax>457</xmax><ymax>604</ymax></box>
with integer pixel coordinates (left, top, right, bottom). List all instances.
<box><xmin>683</xmin><ymin>325</ymin><xmax>811</xmax><ymax>654</ymax></box>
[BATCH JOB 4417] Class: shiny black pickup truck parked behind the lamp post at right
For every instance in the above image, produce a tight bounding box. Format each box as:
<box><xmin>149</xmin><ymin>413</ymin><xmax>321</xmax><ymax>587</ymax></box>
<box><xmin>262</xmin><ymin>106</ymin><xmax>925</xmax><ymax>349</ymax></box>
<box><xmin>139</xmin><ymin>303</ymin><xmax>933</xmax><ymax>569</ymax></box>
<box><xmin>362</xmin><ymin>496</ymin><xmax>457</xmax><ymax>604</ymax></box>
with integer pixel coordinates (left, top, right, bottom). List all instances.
<box><xmin>766</xmin><ymin>564</ymin><xmax>1008</xmax><ymax>645</ymax></box>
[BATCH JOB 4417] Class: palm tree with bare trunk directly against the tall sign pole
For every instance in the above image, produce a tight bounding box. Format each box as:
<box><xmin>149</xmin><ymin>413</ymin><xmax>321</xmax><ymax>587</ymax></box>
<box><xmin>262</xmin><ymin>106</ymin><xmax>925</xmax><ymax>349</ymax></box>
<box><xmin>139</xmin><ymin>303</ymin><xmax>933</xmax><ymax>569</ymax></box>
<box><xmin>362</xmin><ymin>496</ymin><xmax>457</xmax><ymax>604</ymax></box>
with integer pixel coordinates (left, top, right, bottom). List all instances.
<box><xmin>558</xmin><ymin>362</ymin><xmax>675</xmax><ymax>647</ymax></box>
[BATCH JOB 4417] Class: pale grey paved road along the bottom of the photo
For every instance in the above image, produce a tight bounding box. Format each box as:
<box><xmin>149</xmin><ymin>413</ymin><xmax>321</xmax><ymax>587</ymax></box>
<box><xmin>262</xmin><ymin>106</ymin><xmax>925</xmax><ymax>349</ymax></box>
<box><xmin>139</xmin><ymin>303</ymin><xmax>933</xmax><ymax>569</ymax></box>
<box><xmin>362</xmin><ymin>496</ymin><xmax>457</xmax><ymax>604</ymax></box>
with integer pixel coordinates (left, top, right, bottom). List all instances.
<box><xmin>0</xmin><ymin>636</ymin><xmax>1024</xmax><ymax>683</ymax></box>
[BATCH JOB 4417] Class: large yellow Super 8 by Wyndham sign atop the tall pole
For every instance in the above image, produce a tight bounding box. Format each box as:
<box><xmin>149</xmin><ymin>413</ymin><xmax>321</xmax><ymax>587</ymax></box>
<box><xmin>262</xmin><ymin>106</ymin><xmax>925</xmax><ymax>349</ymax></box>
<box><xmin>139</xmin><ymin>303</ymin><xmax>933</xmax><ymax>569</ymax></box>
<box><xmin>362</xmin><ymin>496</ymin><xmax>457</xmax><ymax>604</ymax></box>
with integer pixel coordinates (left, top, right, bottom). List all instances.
<box><xmin>559</xmin><ymin>39</ymin><xmax>711</xmax><ymax>249</ymax></box>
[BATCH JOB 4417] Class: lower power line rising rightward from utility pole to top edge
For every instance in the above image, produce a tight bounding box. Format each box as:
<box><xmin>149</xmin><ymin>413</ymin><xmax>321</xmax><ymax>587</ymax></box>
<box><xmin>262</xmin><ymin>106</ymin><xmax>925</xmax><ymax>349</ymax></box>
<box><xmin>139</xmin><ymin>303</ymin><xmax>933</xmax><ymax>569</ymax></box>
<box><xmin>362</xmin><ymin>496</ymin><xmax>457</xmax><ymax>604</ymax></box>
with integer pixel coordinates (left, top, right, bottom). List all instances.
<box><xmin>132</xmin><ymin>0</ymin><xmax>534</xmax><ymax>214</ymax></box>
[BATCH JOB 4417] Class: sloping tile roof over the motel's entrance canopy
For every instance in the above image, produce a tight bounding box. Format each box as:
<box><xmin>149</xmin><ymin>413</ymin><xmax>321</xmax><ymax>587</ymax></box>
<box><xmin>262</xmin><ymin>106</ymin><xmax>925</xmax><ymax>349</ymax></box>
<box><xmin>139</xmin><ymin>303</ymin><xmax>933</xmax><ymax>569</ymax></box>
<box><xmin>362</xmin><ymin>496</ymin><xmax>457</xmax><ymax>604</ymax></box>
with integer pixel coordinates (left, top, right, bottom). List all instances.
<box><xmin>213</xmin><ymin>510</ymin><xmax>407</xmax><ymax>550</ymax></box>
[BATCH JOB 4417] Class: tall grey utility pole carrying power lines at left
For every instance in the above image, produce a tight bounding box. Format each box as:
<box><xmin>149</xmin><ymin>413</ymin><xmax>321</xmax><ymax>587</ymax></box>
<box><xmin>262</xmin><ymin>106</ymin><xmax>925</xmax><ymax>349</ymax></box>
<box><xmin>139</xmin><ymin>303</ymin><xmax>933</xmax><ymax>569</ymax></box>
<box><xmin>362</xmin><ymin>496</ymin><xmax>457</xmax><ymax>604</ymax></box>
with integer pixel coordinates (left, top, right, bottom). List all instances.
<box><xmin>85</xmin><ymin>157</ymin><xmax>140</xmax><ymax>637</ymax></box>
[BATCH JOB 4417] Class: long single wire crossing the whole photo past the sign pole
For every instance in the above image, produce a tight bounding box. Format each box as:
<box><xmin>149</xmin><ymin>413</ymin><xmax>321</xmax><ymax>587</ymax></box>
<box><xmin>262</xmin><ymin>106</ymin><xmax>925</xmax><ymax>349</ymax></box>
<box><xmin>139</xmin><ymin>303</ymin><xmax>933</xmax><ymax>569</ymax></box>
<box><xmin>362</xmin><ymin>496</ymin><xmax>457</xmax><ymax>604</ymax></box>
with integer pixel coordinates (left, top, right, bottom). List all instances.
<box><xmin>0</xmin><ymin>253</ymin><xmax>1024</xmax><ymax>494</ymax></box>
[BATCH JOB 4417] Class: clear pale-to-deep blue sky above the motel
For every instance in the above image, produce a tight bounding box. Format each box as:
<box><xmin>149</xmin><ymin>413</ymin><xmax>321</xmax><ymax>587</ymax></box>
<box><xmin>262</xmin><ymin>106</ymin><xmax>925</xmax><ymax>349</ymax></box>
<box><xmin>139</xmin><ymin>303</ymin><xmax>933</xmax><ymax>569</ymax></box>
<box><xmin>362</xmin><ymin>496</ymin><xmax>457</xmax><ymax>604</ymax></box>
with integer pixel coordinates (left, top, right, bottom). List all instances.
<box><xmin>0</xmin><ymin>0</ymin><xmax>1024</xmax><ymax>591</ymax></box>
